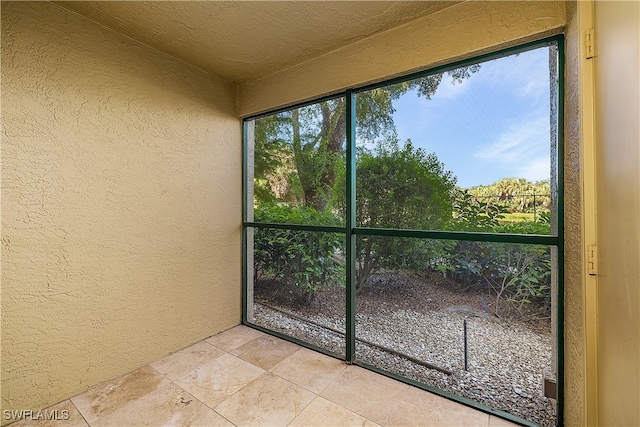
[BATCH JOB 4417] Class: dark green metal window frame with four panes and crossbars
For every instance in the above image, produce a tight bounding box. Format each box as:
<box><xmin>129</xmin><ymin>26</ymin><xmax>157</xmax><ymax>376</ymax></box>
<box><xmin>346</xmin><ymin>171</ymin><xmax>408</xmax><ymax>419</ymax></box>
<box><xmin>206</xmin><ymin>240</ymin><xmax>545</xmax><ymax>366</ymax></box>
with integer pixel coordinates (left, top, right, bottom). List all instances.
<box><xmin>242</xmin><ymin>35</ymin><xmax>564</xmax><ymax>425</ymax></box>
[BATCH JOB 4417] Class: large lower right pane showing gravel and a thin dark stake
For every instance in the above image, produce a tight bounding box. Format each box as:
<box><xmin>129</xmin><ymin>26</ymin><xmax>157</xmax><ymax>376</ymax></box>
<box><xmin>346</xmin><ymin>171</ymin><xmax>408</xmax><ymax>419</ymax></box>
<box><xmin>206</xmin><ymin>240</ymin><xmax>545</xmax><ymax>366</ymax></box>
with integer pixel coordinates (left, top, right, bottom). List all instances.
<box><xmin>356</xmin><ymin>236</ymin><xmax>556</xmax><ymax>425</ymax></box>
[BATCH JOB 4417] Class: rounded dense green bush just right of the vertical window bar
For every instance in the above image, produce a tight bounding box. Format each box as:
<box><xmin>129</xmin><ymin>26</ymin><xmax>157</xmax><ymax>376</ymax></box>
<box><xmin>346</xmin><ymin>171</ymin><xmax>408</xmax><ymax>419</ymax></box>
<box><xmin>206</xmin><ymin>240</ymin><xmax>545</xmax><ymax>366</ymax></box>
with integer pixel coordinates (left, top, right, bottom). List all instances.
<box><xmin>356</xmin><ymin>141</ymin><xmax>455</xmax><ymax>289</ymax></box>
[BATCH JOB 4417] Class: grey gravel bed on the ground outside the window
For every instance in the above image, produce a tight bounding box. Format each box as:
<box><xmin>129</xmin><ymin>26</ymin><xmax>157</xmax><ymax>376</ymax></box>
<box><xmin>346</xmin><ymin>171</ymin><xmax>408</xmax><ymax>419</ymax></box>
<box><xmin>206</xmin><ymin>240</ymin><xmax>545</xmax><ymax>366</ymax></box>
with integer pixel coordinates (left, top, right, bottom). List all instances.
<box><xmin>254</xmin><ymin>277</ymin><xmax>556</xmax><ymax>426</ymax></box>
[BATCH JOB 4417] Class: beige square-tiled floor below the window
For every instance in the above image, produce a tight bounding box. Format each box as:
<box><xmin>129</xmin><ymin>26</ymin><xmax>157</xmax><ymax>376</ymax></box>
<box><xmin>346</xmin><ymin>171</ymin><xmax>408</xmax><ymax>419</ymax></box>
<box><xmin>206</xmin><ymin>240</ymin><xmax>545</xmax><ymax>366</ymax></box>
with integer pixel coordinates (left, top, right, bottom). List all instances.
<box><xmin>12</xmin><ymin>326</ymin><xmax>515</xmax><ymax>427</ymax></box>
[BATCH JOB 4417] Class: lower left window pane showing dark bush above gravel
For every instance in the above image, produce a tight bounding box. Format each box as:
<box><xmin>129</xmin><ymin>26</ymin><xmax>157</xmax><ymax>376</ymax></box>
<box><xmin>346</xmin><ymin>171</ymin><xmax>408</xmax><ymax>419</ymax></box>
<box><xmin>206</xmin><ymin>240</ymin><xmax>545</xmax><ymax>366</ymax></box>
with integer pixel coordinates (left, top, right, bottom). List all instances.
<box><xmin>247</xmin><ymin>229</ymin><xmax>346</xmax><ymax>357</ymax></box>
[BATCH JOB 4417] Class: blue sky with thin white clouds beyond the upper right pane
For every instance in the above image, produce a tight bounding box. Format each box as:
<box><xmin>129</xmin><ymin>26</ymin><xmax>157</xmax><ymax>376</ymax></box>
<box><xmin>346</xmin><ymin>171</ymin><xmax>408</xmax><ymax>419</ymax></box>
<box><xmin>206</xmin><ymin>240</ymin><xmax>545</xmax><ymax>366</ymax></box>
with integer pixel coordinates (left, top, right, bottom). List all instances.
<box><xmin>394</xmin><ymin>47</ymin><xmax>550</xmax><ymax>188</ymax></box>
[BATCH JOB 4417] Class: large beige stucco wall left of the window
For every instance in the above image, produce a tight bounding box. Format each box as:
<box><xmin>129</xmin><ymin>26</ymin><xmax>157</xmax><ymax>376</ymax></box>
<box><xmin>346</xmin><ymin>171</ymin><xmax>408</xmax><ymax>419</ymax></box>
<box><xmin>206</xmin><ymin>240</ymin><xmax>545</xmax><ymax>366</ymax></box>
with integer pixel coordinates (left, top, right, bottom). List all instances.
<box><xmin>1</xmin><ymin>2</ymin><xmax>241</xmax><ymax>409</ymax></box>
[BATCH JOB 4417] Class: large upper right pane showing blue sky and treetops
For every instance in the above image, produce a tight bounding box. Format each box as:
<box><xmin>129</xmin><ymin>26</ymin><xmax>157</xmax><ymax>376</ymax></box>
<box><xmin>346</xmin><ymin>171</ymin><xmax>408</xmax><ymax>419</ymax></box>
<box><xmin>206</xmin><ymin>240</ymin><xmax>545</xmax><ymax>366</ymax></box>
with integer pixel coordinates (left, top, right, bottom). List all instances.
<box><xmin>356</xmin><ymin>46</ymin><xmax>557</xmax><ymax>234</ymax></box>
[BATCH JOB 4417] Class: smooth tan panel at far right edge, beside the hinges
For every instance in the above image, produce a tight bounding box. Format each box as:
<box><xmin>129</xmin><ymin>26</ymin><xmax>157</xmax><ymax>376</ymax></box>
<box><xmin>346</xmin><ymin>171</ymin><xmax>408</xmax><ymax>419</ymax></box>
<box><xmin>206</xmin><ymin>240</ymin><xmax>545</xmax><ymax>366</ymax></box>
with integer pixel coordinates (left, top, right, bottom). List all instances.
<box><xmin>594</xmin><ymin>1</ymin><xmax>640</xmax><ymax>426</ymax></box>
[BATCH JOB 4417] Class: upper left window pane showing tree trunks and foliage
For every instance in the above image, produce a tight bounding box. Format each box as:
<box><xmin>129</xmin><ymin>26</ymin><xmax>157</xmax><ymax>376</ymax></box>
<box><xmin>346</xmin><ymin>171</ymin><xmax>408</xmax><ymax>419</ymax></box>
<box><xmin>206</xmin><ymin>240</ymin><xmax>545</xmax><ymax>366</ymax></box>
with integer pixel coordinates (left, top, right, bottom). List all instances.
<box><xmin>247</xmin><ymin>97</ymin><xmax>346</xmax><ymax>225</ymax></box>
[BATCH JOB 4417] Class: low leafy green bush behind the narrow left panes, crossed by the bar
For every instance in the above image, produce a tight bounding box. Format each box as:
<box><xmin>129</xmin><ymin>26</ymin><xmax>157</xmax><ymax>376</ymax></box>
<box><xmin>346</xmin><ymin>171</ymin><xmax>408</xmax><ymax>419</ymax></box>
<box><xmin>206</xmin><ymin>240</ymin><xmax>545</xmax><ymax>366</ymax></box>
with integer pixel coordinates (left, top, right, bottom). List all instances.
<box><xmin>254</xmin><ymin>205</ymin><xmax>344</xmax><ymax>303</ymax></box>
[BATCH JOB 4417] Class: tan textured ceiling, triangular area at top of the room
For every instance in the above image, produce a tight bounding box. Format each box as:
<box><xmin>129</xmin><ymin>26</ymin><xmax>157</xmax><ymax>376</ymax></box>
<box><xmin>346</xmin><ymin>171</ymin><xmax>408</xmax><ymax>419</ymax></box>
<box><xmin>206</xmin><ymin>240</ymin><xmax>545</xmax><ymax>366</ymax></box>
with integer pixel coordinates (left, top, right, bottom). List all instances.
<box><xmin>57</xmin><ymin>1</ymin><xmax>456</xmax><ymax>84</ymax></box>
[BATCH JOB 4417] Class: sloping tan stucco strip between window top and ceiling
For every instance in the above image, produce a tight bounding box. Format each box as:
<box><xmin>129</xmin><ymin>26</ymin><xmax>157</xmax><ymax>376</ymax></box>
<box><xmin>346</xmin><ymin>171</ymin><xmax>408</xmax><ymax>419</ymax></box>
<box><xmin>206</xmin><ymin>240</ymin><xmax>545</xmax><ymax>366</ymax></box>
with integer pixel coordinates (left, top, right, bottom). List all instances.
<box><xmin>238</xmin><ymin>1</ymin><xmax>565</xmax><ymax>116</ymax></box>
